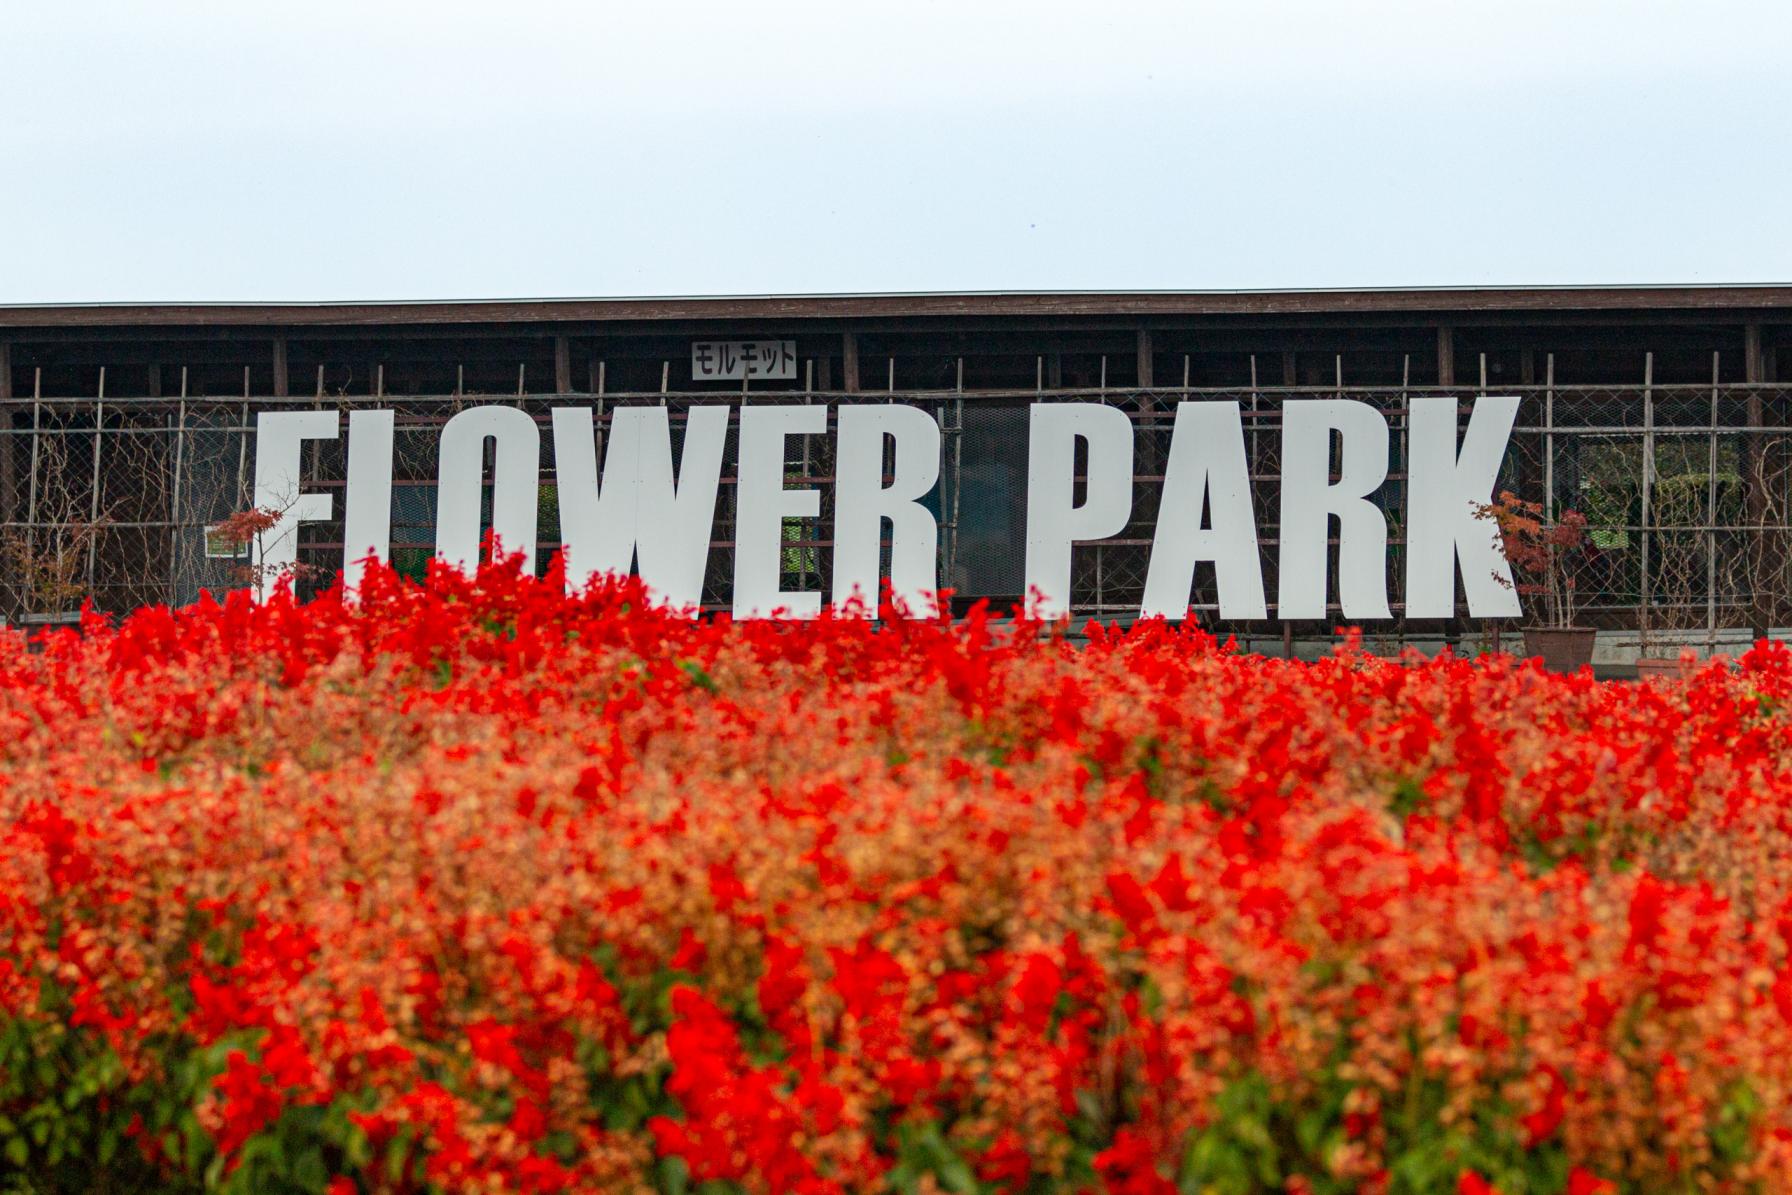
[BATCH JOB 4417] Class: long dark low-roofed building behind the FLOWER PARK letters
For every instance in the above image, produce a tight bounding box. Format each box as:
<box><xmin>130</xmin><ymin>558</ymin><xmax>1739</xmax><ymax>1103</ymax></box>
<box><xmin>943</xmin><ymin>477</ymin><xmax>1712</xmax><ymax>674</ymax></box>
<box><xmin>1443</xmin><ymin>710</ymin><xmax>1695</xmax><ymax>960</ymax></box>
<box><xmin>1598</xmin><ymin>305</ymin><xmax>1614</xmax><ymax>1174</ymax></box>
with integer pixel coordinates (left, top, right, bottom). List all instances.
<box><xmin>0</xmin><ymin>287</ymin><xmax>1792</xmax><ymax>638</ymax></box>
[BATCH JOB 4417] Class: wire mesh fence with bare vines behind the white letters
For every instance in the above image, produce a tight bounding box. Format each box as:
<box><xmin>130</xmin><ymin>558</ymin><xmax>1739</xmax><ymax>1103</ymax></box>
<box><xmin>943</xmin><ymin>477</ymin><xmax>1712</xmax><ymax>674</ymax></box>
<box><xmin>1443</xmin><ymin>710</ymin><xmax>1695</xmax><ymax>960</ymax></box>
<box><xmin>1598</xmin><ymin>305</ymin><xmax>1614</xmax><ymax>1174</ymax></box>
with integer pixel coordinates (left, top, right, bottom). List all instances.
<box><xmin>0</xmin><ymin>383</ymin><xmax>1792</xmax><ymax>640</ymax></box>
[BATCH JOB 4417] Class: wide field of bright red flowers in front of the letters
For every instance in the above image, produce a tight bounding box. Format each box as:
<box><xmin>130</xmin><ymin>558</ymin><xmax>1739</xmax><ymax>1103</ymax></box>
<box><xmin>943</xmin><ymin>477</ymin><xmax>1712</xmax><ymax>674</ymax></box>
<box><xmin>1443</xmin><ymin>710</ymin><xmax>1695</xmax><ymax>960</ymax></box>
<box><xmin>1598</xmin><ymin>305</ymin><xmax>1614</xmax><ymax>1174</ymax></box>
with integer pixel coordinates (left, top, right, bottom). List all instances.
<box><xmin>0</xmin><ymin>570</ymin><xmax>1792</xmax><ymax>1195</ymax></box>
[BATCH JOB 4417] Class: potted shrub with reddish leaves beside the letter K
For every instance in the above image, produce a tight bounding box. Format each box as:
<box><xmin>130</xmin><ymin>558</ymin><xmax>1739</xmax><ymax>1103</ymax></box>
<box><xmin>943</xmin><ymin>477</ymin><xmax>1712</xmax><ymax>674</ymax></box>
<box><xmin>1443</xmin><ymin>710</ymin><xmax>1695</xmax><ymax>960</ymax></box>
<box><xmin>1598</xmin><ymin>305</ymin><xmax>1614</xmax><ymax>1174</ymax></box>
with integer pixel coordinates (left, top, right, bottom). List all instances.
<box><xmin>1475</xmin><ymin>491</ymin><xmax>1597</xmax><ymax>672</ymax></box>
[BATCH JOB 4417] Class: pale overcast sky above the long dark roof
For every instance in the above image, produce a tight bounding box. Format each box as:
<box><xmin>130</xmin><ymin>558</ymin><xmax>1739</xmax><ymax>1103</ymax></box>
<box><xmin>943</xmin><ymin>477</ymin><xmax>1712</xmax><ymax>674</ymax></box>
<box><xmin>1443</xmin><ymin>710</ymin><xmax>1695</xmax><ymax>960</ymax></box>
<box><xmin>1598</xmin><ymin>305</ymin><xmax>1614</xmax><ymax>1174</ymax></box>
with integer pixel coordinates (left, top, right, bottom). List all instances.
<box><xmin>0</xmin><ymin>0</ymin><xmax>1792</xmax><ymax>303</ymax></box>
